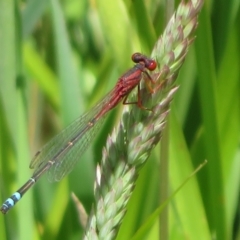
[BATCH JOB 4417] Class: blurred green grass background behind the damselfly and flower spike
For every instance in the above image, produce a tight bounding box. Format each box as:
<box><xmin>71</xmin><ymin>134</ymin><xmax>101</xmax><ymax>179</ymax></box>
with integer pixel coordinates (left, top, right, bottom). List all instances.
<box><xmin>0</xmin><ymin>0</ymin><xmax>240</xmax><ymax>240</ymax></box>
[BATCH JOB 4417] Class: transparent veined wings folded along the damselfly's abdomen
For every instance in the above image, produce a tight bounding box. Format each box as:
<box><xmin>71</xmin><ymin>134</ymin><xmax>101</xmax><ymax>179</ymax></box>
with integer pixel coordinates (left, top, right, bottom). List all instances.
<box><xmin>30</xmin><ymin>92</ymin><xmax>112</xmax><ymax>181</ymax></box>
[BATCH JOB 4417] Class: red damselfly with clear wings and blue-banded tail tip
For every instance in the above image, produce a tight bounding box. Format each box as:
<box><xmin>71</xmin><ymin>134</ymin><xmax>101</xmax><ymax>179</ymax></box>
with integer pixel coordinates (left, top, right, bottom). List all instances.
<box><xmin>0</xmin><ymin>53</ymin><xmax>157</xmax><ymax>214</ymax></box>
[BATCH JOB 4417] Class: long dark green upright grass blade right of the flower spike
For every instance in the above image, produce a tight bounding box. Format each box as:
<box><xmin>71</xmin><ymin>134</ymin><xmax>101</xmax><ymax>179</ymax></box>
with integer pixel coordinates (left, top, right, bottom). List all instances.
<box><xmin>196</xmin><ymin>4</ymin><xmax>227</xmax><ymax>239</ymax></box>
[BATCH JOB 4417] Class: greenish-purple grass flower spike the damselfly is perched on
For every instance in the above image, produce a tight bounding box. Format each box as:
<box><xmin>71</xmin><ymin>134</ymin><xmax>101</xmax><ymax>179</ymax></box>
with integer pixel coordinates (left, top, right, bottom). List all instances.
<box><xmin>85</xmin><ymin>0</ymin><xmax>203</xmax><ymax>239</ymax></box>
